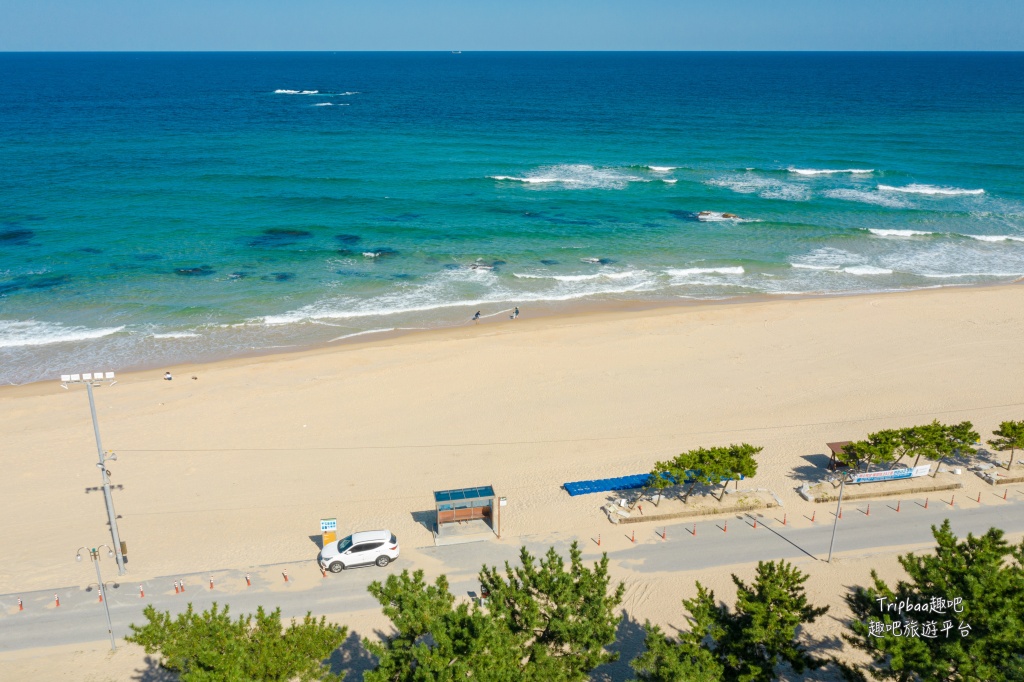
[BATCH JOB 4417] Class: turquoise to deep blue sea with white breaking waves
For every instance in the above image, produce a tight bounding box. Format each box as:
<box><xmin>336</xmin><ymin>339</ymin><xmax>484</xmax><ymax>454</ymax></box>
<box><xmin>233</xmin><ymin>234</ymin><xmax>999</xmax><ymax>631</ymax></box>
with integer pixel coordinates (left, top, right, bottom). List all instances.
<box><xmin>0</xmin><ymin>52</ymin><xmax>1024</xmax><ymax>383</ymax></box>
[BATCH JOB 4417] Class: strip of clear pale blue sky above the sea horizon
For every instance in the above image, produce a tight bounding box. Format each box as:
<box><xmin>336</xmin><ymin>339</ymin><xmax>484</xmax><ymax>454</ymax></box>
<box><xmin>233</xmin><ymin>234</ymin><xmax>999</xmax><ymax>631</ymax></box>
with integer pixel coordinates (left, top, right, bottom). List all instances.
<box><xmin>0</xmin><ymin>0</ymin><xmax>1024</xmax><ymax>51</ymax></box>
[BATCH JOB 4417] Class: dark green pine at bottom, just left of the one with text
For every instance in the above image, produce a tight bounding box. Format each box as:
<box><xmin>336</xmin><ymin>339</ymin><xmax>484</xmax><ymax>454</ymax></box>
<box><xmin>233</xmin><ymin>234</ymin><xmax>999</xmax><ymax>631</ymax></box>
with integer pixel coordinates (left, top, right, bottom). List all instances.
<box><xmin>632</xmin><ymin>561</ymin><xmax>828</xmax><ymax>682</ymax></box>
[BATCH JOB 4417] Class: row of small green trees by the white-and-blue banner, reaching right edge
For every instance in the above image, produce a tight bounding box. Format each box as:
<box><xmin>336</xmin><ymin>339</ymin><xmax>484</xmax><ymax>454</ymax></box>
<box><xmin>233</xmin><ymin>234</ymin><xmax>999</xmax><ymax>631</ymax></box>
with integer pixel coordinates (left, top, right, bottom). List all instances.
<box><xmin>837</xmin><ymin>420</ymin><xmax>1024</xmax><ymax>471</ymax></box>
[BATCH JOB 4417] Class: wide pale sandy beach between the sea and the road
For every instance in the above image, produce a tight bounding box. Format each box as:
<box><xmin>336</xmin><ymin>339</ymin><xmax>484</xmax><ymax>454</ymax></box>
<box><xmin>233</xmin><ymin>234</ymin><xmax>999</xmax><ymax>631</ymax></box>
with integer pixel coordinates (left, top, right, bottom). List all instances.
<box><xmin>0</xmin><ymin>286</ymin><xmax>1024</xmax><ymax>679</ymax></box>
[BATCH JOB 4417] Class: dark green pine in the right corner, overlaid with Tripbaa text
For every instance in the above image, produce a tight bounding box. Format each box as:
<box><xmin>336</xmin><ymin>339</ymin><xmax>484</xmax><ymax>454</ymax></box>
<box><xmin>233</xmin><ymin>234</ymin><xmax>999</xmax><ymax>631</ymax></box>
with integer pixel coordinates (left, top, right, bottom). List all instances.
<box><xmin>846</xmin><ymin>519</ymin><xmax>1024</xmax><ymax>682</ymax></box>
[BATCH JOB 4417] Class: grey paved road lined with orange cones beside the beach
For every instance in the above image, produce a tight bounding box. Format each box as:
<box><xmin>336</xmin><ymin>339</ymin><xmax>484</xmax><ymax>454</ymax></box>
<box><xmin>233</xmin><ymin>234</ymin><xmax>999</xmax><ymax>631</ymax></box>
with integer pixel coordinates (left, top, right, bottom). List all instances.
<box><xmin>0</xmin><ymin>494</ymin><xmax>1024</xmax><ymax>651</ymax></box>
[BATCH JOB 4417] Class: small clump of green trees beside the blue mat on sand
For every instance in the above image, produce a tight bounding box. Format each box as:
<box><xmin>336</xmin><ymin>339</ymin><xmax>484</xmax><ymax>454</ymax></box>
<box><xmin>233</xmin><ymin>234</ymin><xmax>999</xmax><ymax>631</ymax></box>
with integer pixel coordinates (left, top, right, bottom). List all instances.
<box><xmin>644</xmin><ymin>442</ymin><xmax>764</xmax><ymax>503</ymax></box>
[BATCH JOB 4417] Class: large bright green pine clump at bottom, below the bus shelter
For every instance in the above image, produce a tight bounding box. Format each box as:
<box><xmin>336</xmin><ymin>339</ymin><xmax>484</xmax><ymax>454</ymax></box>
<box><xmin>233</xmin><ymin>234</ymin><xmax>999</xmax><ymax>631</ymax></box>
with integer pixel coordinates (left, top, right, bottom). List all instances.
<box><xmin>364</xmin><ymin>543</ymin><xmax>625</xmax><ymax>682</ymax></box>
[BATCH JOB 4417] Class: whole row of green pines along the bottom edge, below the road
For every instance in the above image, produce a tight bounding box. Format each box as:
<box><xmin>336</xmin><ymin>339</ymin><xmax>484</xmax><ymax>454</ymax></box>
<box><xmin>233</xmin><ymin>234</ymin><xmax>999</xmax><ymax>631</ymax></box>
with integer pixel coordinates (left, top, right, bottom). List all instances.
<box><xmin>127</xmin><ymin>520</ymin><xmax>1024</xmax><ymax>682</ymax></box>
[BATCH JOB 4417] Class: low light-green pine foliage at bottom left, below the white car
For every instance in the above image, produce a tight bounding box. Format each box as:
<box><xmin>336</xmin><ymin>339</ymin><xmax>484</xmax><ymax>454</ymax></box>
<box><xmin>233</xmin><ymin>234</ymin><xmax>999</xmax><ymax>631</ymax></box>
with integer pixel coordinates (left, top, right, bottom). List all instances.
<box><xmin>125</xmin><ymin>603</ymin><xmax>347</xmax><ymax>682</ymax></box>
